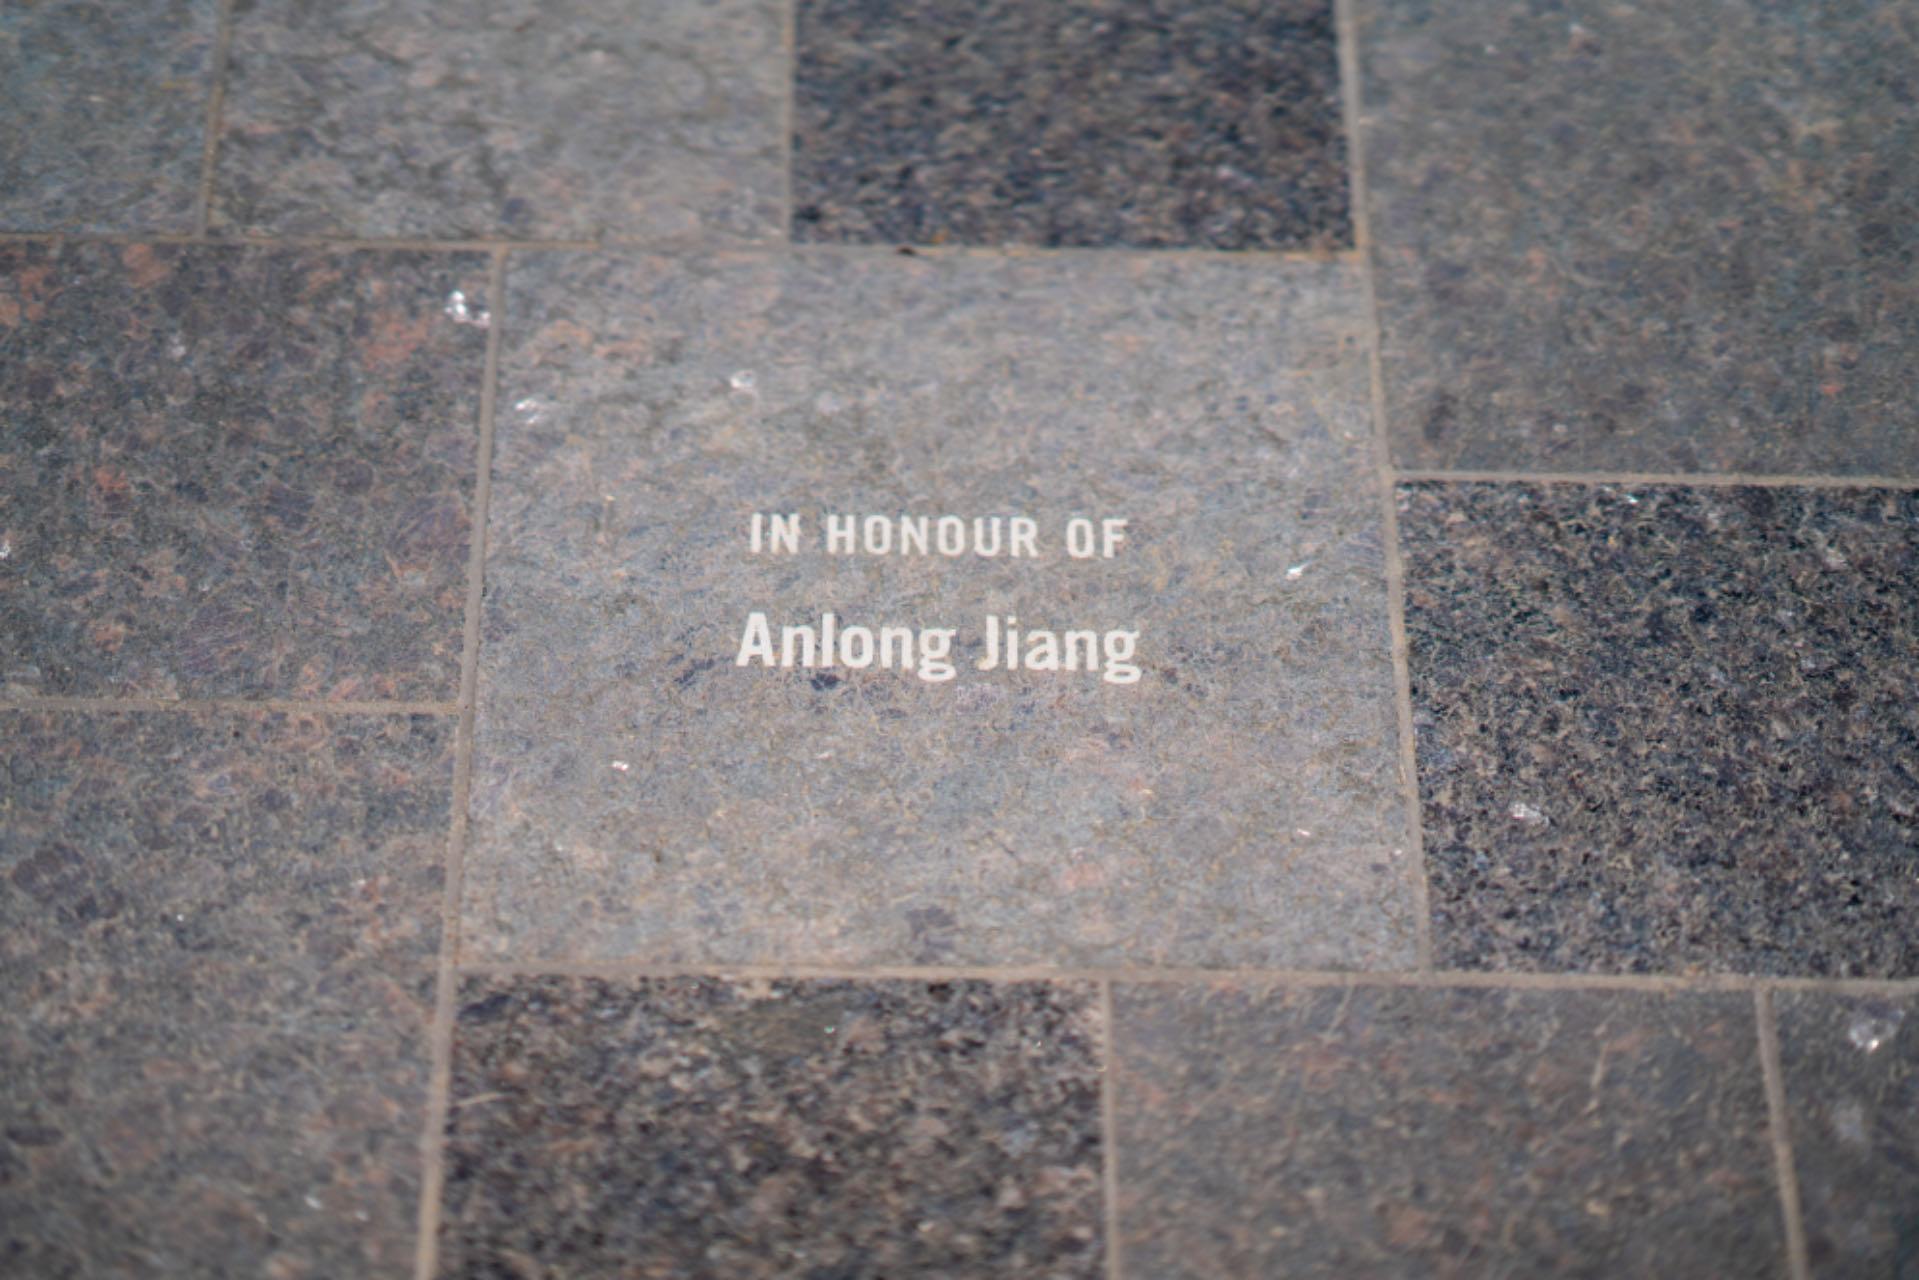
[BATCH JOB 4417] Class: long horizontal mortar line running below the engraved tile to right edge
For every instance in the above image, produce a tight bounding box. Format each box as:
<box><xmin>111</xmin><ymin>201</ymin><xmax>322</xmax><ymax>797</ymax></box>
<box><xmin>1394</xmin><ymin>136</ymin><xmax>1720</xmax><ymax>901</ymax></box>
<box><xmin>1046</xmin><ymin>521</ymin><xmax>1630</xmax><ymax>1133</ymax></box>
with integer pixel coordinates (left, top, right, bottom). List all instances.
<box><xmin>445</xmin><ymin>960</ymin><xmax>1919</xmax><ymax>996</ymax></box>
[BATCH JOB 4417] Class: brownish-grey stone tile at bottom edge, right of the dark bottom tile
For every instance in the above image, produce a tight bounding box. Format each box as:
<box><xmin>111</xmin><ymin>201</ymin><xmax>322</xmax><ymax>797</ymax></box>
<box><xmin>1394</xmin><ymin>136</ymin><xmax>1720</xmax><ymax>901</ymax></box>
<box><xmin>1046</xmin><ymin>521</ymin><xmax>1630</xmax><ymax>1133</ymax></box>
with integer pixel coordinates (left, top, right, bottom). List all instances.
<box><xmin>1113</xmin><ymin>984</ymin><xmax>1787</xmax><ymax>1280</ymax></box>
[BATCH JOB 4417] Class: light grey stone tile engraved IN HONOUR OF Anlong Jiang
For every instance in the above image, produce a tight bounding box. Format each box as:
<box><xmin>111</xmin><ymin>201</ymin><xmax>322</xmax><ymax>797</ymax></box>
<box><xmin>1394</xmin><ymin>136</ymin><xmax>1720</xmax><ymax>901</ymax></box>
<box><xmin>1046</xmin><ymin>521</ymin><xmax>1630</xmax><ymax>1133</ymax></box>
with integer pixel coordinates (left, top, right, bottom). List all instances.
<box><xmin>462</xmin><ymin>251</ymin><xmax>1416</xmax><ymax>967</ymax></box>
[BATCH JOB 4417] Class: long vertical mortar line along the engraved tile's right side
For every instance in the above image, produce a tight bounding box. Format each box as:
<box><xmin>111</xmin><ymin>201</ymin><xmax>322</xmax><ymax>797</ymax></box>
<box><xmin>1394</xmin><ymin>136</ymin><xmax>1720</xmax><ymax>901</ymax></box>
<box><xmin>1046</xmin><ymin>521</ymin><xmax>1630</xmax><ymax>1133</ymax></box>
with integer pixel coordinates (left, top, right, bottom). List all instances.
<box><xmin>1334</xmin><ymin>0</ymin><xmax>1433</xmax><ymax>973</ymax></box>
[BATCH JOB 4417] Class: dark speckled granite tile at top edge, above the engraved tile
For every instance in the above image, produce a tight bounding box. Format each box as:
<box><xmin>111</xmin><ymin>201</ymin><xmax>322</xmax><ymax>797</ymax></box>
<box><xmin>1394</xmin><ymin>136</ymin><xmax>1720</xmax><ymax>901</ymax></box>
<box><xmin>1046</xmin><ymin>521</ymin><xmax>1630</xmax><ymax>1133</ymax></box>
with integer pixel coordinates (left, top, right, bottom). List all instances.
<box><xmin>793</xmin><ymin>0</ymin><xmax>1351</xmax><ymax>249</ymax></box>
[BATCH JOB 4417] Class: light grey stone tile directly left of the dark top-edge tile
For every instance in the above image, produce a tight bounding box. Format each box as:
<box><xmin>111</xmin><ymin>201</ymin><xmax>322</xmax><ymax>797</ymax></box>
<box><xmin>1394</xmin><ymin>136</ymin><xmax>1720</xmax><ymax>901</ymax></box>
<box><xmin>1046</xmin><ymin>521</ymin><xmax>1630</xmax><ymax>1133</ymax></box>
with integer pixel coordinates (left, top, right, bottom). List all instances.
<box><xmin>213</xmin><ymin>0</ymin><xmax>787</xmax><ymax>242</ymax></box>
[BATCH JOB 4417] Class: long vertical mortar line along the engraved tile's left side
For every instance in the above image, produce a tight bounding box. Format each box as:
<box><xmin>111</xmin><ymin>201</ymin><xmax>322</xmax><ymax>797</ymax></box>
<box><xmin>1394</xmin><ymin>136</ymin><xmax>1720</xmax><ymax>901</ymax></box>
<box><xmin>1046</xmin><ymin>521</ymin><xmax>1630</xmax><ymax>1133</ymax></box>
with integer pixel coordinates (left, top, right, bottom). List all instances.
<box><xmin>415</xmin><ymin>249</ymin><xmax>507</xmax><ymax>1280</ymax></box>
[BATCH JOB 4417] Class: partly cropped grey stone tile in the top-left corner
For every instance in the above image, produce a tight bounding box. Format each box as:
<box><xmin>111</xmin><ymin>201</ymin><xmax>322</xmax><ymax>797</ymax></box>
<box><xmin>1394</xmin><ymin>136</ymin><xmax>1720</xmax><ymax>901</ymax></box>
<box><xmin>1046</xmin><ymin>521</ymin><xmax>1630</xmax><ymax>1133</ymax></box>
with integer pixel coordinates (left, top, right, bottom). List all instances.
<box><xmin>0</xmin><ymin>0</ymin><xmax>219</xmax><ymax>232</ymax></box>
